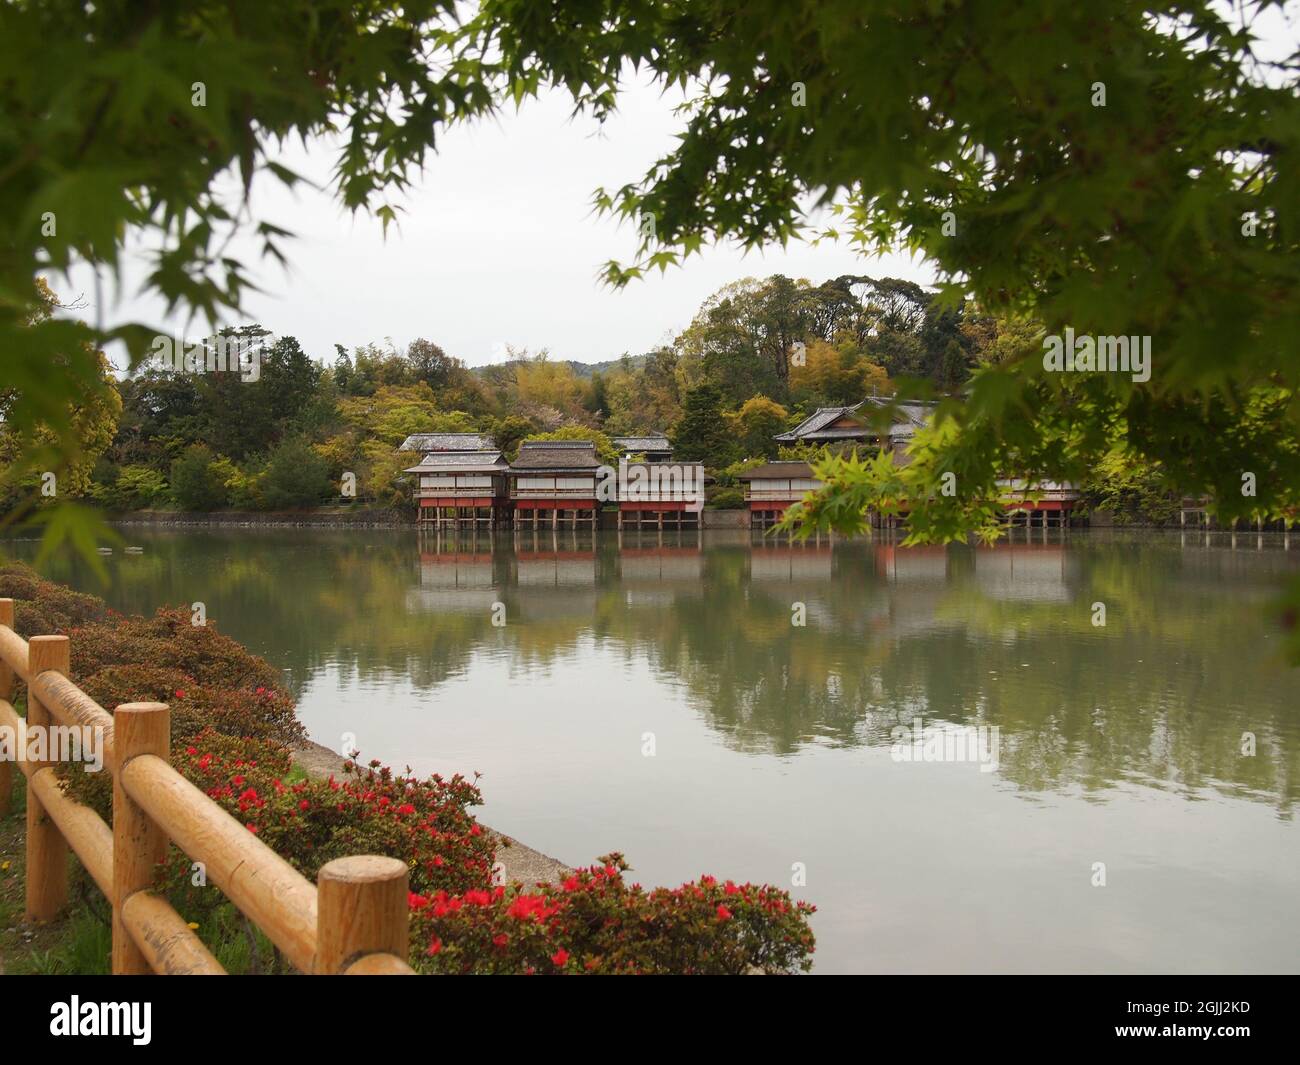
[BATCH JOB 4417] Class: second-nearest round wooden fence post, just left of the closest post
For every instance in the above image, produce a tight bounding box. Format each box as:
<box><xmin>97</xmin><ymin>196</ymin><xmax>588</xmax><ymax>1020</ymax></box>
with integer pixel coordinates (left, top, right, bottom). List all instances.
<box><xmin>112</xmin><ymin>702</ymin><xmax>172</xmax><ymax>977</ymax></box>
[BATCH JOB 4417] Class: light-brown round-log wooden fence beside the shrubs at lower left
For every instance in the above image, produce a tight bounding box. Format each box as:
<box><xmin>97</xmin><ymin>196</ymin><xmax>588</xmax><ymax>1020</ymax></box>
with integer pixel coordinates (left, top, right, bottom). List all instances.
<box><xmin>0</xmin><ymin>599</ymin><xmax>413</xmax><ymax>975</ymax></box>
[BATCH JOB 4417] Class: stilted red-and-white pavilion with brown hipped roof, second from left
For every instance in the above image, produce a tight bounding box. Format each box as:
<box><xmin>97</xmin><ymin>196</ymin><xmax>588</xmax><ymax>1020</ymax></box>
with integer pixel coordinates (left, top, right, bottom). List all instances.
<box><xmin>510</xmin><ymin>440</ymin><xmax>601</xmax><ymax>529</ymax></box>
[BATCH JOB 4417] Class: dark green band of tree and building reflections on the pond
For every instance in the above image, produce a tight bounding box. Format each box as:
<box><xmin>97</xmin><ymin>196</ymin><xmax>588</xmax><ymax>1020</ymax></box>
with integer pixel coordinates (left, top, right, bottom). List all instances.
<box><xmin>22</xmin><ymin>529</ymin><xmax>1300</xmax><ymax>817</ymax></box>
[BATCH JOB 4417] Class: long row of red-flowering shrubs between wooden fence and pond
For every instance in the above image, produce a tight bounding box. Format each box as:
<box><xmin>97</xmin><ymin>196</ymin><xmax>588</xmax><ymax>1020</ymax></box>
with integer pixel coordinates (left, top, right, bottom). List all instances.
<box><xmin>0</xmin><ymin>564</ymin><xmax>814</xmax><ymax>974</ymax></box>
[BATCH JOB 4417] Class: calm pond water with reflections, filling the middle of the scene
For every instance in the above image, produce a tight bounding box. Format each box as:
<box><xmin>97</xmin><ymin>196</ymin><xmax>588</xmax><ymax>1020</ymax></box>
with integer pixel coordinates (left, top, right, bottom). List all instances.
<box><xmin>9</xmin><ymin>529</ymin><xmax>1300</xmax><ymax>973</ymax></box>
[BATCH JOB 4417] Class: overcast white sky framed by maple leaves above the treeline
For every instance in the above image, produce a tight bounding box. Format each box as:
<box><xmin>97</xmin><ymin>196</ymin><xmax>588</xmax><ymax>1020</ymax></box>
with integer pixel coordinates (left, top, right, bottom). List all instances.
<box><xmin>65</xmin><ymin>72</ymin><xmax>932</xmax><ymax>365</ymax></box>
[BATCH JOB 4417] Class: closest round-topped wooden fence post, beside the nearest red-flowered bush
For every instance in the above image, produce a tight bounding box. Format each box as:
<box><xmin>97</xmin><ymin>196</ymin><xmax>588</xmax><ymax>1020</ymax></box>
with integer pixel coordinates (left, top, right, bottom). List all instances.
<box><xmin>315</xmin><ymin>854</ymin><xmax>411</xmax><ymax>974</ymax></box>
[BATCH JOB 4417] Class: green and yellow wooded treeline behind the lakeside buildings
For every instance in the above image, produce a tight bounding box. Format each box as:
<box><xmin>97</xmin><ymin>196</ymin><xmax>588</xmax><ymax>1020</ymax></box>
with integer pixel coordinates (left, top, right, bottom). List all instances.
<box><xmin>0</xmin><ymin>274</ymin><xmax>1159</xmax><ymax>511</ymax></box>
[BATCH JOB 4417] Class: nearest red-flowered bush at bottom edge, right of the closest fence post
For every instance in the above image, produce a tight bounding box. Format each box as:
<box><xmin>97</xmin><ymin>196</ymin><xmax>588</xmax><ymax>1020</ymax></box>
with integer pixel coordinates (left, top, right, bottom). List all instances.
<box><xmin>411</xmin><ymin>854</ymin><xmax>814</xmax><ymax>975</ymax></box>
